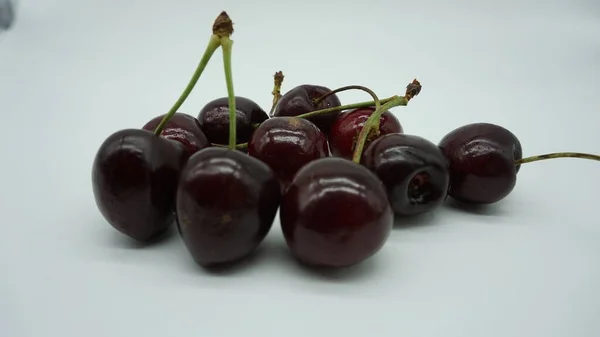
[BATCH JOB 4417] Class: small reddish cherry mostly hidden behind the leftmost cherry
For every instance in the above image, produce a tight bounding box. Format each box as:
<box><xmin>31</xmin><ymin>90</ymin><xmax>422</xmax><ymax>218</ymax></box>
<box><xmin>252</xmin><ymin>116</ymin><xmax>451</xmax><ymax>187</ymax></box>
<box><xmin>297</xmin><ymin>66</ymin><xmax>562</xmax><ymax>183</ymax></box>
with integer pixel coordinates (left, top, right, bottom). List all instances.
<box><xmin>142</xmin><ymin>112</ymin><xmax>210</xmax><ymax>156</ymax></box>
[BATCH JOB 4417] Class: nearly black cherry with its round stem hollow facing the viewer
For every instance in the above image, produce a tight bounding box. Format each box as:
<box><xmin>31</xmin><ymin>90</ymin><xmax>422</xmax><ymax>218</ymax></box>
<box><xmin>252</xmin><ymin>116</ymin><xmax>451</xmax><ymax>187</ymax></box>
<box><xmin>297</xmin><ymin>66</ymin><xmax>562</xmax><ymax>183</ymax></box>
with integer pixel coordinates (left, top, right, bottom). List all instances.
<box><xmin>361</xmin><ymin>133</ymin><xmax>450</xmax><ymax>216</ymax></box>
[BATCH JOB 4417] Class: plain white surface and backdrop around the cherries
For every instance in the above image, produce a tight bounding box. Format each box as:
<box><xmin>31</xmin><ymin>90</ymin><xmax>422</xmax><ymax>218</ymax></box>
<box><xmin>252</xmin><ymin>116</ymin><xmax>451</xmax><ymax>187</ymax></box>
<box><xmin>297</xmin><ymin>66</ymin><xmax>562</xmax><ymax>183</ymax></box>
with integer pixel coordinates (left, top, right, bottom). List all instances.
<box><xmin>0</xmin><ymin>0</ymin><xmax>600</xmax><ymax>337</ymax></box>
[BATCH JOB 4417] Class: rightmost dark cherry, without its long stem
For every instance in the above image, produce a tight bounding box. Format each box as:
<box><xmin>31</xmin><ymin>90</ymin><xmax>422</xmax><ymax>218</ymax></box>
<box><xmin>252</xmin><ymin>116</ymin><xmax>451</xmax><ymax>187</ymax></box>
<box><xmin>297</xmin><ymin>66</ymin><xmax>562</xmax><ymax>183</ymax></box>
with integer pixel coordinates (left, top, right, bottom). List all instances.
<box><xmin>438</xmin><ymin>123</ymin><xmax>523</xmax><ymax>204</ymax></box>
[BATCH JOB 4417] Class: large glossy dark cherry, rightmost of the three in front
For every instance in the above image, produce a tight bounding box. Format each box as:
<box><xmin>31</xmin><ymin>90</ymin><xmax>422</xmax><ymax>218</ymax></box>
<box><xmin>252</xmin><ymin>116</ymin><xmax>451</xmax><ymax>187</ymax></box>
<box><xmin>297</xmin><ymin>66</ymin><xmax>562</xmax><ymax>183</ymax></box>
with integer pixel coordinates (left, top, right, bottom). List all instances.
<box><xmin>280</xmin><ymin>157</ymin><xmax>393</xmax><ymax>267</ymax></box>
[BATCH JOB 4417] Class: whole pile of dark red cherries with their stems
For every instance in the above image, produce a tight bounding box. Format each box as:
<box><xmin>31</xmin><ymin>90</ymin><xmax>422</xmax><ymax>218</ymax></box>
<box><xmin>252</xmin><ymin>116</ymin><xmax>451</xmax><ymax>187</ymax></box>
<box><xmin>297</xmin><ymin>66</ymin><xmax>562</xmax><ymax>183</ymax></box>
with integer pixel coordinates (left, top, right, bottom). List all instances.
<box><xmin>92</xmin><ymin>12</ymin><xmax>600</xmax><ymax>268</ymax></box>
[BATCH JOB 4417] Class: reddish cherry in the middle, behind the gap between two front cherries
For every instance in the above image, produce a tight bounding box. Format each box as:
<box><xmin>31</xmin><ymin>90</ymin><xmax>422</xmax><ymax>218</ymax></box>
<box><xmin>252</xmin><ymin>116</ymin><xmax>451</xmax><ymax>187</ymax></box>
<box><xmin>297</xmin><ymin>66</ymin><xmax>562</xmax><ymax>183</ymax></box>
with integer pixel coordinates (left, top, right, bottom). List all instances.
<box><xmin>248</xmin><ymin>117</ymin><xmax>329</xmax><ymax>191</ymax></box>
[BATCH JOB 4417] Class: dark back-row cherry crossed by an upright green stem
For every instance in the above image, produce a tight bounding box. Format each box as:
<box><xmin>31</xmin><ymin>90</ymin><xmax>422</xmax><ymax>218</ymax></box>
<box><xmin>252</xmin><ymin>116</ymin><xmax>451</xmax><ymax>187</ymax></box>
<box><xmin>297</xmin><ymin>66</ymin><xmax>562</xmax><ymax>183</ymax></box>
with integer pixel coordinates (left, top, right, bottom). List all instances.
<box><xmin>198</xmin><ymin>96</ymin><xmax>269</xmax><ymax>145</ymax></box>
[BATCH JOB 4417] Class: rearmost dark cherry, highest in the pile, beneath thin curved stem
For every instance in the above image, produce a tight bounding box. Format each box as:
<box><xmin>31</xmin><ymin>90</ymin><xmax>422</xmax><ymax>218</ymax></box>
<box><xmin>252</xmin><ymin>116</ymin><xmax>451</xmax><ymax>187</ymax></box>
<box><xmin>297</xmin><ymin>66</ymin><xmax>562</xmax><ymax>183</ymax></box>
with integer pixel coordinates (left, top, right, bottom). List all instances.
<box><xmin>273</xmin><ymin>84</ymin><xmax>341</xmax><ymax>134</ymax></box>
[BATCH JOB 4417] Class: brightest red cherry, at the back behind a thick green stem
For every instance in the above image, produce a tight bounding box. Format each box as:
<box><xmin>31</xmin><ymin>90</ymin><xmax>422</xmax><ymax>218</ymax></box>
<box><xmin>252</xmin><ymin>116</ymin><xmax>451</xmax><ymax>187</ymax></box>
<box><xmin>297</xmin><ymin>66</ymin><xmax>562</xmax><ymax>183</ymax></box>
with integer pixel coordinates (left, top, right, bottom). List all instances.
<box><xmin>328</xmin><ymin>107</ymin><xmax>404</xmax><ymax>159</ymax></box>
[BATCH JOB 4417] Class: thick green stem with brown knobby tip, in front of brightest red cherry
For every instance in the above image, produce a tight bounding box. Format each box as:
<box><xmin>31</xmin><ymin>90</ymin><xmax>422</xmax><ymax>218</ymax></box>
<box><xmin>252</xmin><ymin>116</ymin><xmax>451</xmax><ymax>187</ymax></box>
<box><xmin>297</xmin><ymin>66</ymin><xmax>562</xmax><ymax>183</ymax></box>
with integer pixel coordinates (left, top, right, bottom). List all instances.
<box><xmin>352</xmin><ymin>79</ymin><xmax>421</xmax><ymax>164</ymax></box>
